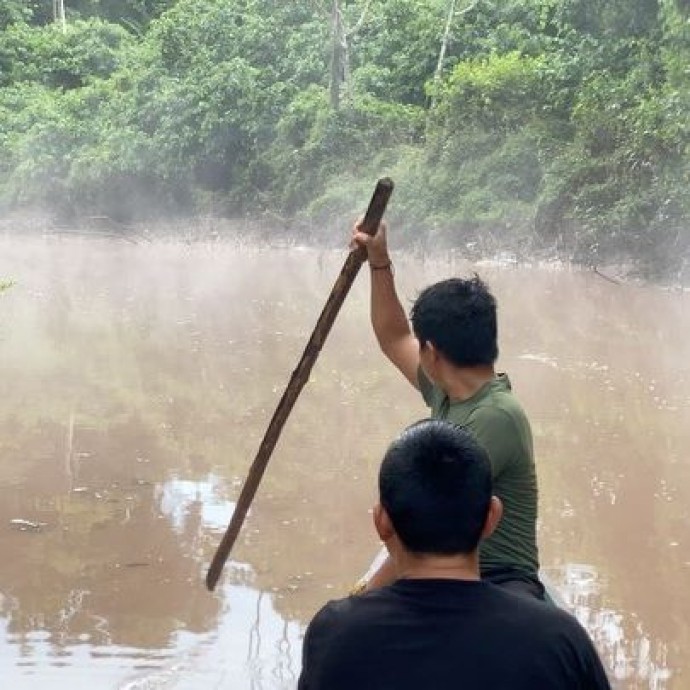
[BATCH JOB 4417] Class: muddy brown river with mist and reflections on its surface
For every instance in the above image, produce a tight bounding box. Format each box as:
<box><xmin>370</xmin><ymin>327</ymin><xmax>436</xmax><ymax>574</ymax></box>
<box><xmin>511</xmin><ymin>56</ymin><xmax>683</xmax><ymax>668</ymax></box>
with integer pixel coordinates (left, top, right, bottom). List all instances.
<box><xmin>0</xmin><ymin>230</ymin><xmax>690</xmax><ymax>690</ymax></box>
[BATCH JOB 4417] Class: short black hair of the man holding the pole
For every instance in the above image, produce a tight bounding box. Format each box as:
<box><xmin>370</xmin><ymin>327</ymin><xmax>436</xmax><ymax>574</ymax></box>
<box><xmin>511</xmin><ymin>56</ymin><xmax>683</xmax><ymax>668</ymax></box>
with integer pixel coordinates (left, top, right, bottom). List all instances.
<box><xmin>410</xmin><ymin>274</ymin><xmax>498</xmax><ymax>366</ymax></box>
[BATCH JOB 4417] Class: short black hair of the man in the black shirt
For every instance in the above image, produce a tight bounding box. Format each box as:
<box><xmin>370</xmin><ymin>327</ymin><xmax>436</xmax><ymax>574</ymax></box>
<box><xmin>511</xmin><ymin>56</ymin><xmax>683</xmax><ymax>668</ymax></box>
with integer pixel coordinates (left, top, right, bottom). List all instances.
<box><xmin>379</xmin><ymin>419</ymin><xmax>492</xmax><ymax>555</ymax></box>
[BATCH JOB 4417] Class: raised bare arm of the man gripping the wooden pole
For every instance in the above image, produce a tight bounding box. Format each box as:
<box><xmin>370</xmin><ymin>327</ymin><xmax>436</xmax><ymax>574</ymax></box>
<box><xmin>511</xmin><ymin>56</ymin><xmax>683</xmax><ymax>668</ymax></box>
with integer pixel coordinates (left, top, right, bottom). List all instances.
<box><xmin>353</xmin><ymin>222</ymin><xmax>419</xmax><ymax>389</ymax></box>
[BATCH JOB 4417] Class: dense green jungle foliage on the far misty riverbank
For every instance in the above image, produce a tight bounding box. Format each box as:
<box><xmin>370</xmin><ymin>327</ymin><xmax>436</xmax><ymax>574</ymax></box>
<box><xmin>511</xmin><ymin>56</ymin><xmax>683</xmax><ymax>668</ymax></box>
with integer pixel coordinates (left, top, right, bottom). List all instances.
<box><xmin>0</xmin><ymin>0</ymin><xmax>690</xmax><ymax>279</ymax></box>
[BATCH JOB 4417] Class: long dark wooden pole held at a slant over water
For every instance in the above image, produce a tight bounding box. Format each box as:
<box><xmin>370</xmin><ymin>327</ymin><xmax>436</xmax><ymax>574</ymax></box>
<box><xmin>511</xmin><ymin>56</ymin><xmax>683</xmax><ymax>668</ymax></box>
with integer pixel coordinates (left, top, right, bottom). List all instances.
<box><xmin>206</xmin><ymin>177</ymin><xmax>393</xmax><ymax>591</ymax></box>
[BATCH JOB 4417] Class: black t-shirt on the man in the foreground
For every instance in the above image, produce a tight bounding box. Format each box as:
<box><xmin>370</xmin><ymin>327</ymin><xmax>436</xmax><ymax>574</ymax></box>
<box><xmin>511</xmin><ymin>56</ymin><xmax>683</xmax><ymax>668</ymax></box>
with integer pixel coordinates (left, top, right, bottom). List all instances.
<box><xmin>298</xmin><ymin>580</ymin><xmax>610</xmax><ymax>690</ymax></box>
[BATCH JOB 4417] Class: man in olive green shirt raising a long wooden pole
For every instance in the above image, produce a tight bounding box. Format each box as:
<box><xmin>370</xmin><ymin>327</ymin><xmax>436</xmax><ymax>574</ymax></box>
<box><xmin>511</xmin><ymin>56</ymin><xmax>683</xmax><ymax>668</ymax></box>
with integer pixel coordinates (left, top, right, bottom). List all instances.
<box><xmin>353</xmin><ymin>218</ymin><xmax>544</xmax><ymax>598</ymax></box>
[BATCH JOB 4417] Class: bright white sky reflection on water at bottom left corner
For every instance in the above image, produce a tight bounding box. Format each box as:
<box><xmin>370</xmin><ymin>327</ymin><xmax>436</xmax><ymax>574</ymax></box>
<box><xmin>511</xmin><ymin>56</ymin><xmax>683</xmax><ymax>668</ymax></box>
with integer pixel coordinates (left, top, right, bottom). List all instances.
<box><xmin>0</xmin><ymin>576</ymin><xmax>301</xmax><ymax>690</ymax></box>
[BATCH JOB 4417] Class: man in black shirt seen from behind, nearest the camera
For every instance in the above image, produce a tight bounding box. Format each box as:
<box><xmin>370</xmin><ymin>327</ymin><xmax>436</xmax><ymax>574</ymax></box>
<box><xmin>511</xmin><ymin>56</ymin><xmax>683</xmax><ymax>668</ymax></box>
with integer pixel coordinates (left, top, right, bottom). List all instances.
<box><xmin>298</xmin><ymin>420</ymin><xmax>610</xmax><ymax>690</ymax></box>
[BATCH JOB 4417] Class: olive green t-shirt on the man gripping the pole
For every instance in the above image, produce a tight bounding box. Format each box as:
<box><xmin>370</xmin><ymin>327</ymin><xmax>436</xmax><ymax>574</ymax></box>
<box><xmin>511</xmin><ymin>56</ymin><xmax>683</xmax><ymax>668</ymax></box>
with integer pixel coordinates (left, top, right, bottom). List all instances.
<box><xmin>418</xmin><ymin>368</ymin><xmax>539</xmax><ymax>575</ymax></box>
